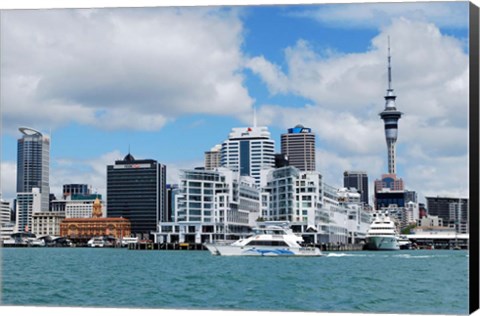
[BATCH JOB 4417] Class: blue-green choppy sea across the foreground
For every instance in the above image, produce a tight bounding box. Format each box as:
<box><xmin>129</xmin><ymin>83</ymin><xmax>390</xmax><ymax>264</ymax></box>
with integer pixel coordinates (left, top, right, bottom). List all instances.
<box><xmin>0</xmin><ymin>248</ymin><xmax>468</xmax><ymax>314</ymax></box>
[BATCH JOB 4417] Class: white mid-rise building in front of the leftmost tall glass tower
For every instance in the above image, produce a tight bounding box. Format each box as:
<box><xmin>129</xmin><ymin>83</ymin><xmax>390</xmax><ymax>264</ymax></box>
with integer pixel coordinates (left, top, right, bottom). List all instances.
<box><xmin>15</xmin><ymin>188</ymin><xmax>42</xmax><ymax>232</ymax></box>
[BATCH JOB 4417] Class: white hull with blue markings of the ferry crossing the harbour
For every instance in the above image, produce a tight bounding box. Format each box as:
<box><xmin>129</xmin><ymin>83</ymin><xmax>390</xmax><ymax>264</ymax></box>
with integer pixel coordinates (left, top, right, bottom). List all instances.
<box><xmin>205</xmin><ymin>244</ymin><xmax>322</xmax><ymax>257</ymax></box>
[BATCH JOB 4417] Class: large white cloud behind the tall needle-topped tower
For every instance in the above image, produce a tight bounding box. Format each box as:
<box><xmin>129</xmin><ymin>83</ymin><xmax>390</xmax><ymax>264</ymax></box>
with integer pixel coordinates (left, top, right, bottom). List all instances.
<box><xmin>248</xmin><ymin>18</ymin><xmax>469</xmax><ymax>199</ymax></box>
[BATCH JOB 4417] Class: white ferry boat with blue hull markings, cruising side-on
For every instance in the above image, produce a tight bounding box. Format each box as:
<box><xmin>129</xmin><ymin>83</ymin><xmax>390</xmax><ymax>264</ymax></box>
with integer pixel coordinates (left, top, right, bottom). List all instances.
<box><xmin>204</xmin><ymin>222</ymin><xmax>322</xmax><ymax>256</ymax></box>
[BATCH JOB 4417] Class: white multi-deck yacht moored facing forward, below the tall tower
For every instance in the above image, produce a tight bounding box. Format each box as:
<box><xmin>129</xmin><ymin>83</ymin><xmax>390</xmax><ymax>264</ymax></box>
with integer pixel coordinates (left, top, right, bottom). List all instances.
<box><xmin>364</xmin><ymin>212</ymin><xmax>400</xmax><ymax>250</ymax></box>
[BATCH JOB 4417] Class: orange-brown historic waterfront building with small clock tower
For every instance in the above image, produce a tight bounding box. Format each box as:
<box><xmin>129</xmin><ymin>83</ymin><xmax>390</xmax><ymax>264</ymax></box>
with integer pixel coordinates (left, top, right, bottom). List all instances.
<box><xmin>60</xmin><ymin>199</ymin><xmax>131</xmax><ymax>243</ymax></box>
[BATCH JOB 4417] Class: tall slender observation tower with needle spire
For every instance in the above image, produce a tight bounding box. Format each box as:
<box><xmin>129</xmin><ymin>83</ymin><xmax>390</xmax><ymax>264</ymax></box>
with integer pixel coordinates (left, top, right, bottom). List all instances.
<box><xmin>379</xmin><ymin>38</ymin><xmax>403</xmax><ymax>174</ymax></box>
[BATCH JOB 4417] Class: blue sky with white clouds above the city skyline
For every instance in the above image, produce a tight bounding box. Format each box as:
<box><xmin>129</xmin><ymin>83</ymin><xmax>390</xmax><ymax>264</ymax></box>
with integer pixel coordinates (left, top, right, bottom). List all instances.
<box><xmin>0</xmin><ymin>2</ymin><xmax>469</xmax><ymax>202</ymax></box>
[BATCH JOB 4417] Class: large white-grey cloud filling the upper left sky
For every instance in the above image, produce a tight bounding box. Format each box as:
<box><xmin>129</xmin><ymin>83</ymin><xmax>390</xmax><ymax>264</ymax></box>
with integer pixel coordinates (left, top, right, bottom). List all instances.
<box><xmin>2</xmin><ymin>7</ymin><xmax>253</xmax><ymax>130</ymax></box>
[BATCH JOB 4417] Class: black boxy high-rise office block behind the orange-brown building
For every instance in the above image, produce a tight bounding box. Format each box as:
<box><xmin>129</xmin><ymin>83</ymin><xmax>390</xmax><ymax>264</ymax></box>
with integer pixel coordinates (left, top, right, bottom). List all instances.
<box><xmin>107</xmin><ymin>153</ymin><xmax>166</xmax><ymax>238</ymax></box>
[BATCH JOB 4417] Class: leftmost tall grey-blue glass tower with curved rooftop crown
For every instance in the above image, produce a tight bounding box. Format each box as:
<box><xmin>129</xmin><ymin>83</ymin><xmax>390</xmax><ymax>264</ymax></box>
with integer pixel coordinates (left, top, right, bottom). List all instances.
<box><xmin>17</xmin><ymin>127</ymin><xmax>50</xmax><ymax>211</ymax></box>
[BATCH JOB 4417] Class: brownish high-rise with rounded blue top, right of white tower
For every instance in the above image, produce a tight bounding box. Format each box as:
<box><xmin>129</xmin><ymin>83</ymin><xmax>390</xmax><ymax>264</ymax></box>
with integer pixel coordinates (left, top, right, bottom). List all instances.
<box><xmin>281</xmin><ymin>125</ymin><xmax>315</xmax><ymax>171</ymax></box>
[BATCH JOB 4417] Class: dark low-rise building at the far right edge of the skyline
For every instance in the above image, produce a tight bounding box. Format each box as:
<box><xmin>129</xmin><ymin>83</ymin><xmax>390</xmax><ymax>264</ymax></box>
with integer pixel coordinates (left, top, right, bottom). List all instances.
<box><xmin>425</xmin><ymin>196</ymin><xmax>469</xmax><ymax>233</ymax></box>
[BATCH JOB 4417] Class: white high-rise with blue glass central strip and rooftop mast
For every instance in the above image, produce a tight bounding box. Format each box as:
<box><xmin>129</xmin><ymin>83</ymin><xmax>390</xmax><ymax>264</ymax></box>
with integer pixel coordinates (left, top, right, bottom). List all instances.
<box><xmin>221</xmin><ymin>127</ymin><xmax>275</xmax><ymax>185</ymax></box>
